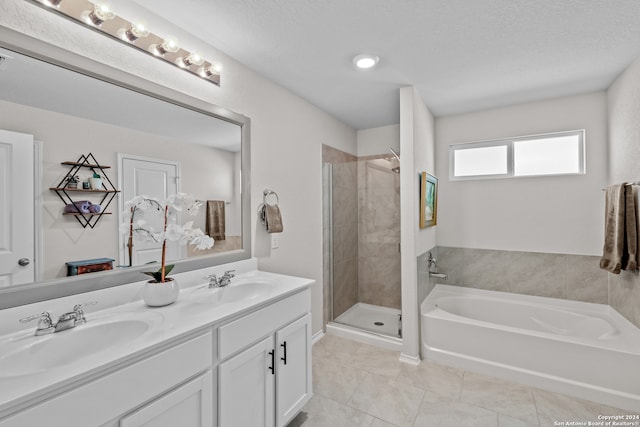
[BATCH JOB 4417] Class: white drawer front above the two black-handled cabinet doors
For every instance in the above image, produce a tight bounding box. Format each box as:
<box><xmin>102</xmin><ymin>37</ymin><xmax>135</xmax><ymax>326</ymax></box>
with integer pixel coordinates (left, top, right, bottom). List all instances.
<box><xmin>218</xmin><ymin>289</ymin><xmax>311</xmax><ymax>360</ymax></box>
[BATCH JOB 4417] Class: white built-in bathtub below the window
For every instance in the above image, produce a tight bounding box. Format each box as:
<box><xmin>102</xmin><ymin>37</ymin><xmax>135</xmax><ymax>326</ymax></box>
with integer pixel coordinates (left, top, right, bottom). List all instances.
<box><xmin>420</xmin><ymin>285</ymin><xmax>640</xmax><ymax>411</ymax></box>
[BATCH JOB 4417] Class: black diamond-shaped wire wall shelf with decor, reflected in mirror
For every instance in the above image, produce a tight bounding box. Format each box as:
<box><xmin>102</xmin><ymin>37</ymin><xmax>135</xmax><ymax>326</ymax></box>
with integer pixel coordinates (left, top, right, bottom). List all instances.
<box><xmin>50</xmin><ymin>153</ymin><xmax>119</xmax><ymax>228</ymax></box>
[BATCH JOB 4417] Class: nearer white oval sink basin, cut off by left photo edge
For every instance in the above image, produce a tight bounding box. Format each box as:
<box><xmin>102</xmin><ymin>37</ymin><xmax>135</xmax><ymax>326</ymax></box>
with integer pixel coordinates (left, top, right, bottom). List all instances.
<box><xmin>0</xmin><ymin>313</ymin><xmax>163</xmax><ymax>378</ymax></box>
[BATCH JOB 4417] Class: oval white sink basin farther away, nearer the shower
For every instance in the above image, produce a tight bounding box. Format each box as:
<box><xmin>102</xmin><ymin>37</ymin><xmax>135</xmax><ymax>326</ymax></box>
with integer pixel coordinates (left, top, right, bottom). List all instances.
<box><xmin>185</xmin><ymin>278</ymin><xmax>276</xmax><ymax>304</ymax></box>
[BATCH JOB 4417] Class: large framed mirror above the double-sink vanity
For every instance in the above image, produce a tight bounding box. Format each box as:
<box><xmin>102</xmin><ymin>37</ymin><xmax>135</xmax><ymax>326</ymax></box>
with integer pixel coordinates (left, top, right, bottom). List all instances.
<box><xmin>0</xmin><ymin>29</ymin><xmax>251</xmax><ymax>308</ymax></box>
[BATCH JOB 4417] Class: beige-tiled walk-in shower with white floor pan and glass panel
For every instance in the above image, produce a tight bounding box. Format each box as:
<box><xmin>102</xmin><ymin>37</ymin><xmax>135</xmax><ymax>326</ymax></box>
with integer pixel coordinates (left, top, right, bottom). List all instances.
<box><xmin>323</xmin><ymin>145</ymin><xmax>402</xmax><ymax>345</ymax></box>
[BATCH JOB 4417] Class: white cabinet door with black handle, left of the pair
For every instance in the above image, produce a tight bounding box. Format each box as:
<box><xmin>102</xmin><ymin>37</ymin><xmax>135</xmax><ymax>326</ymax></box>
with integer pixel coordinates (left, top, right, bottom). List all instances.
<box><xmin>218</xmin><ymin>336</ymin><xmax>277</xmax><ymax>427</ymax></box>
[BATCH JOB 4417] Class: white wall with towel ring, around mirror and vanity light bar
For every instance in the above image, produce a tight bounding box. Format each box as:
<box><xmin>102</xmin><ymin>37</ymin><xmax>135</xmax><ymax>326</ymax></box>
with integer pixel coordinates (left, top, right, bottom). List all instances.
<box><xmin>0</xmin><ymin>0</ymin><xmax>356</xmax><ymax>332</ymax></box>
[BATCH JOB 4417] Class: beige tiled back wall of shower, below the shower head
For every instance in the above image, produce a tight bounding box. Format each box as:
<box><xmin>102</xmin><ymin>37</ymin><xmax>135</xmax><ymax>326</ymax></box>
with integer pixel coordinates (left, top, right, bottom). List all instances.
<box><xmin>358</xmin><ymin>156</ymin><xmax>402</xmax><ymax>309</ymax></box>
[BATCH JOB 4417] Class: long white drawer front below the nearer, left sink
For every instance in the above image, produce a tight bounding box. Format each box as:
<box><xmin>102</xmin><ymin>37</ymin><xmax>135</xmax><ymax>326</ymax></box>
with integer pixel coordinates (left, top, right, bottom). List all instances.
<box><xmin>0</xmin><ymin>332</ymin><xmax>213</xmax><ymax>427</ymax></box>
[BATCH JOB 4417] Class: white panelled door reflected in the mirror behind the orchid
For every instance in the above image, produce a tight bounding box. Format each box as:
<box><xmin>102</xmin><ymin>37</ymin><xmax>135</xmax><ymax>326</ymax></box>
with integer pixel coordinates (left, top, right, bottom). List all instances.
<box><xmin>118</xmin><ymin>154</ymin><xmax>180</xmax><ymax>265</ymax></box>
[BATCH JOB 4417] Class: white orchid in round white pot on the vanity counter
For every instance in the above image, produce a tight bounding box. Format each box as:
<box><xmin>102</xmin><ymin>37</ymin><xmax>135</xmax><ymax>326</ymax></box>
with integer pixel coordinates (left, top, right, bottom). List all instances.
<box><xmin>120</xmin><ymin>193</ymin><xmax>213</xmax><ymax>307</ymax></box>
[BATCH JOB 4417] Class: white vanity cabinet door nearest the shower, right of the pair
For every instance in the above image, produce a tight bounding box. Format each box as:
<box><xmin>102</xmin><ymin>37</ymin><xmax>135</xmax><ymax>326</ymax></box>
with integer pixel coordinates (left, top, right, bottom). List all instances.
<box><xmin>276</xmin><ymin>314</ymin><xmax>312</xmax><ymax>426</ymax></box>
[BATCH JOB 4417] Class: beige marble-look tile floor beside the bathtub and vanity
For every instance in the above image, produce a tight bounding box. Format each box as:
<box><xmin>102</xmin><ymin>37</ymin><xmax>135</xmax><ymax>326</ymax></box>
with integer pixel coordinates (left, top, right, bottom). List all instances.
<box><xmin>288</xmin><ymin>335</ymin><xmax>638</xmax><ymax>427</ymax></box>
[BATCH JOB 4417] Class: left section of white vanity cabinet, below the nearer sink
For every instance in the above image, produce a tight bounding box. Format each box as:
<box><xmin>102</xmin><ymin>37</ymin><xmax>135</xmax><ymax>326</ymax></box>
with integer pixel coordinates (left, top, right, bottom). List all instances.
<box><xmin>0</xmin><ymin>331</ymin><xmax>214</xmax><ymax>427</ymax></box>
